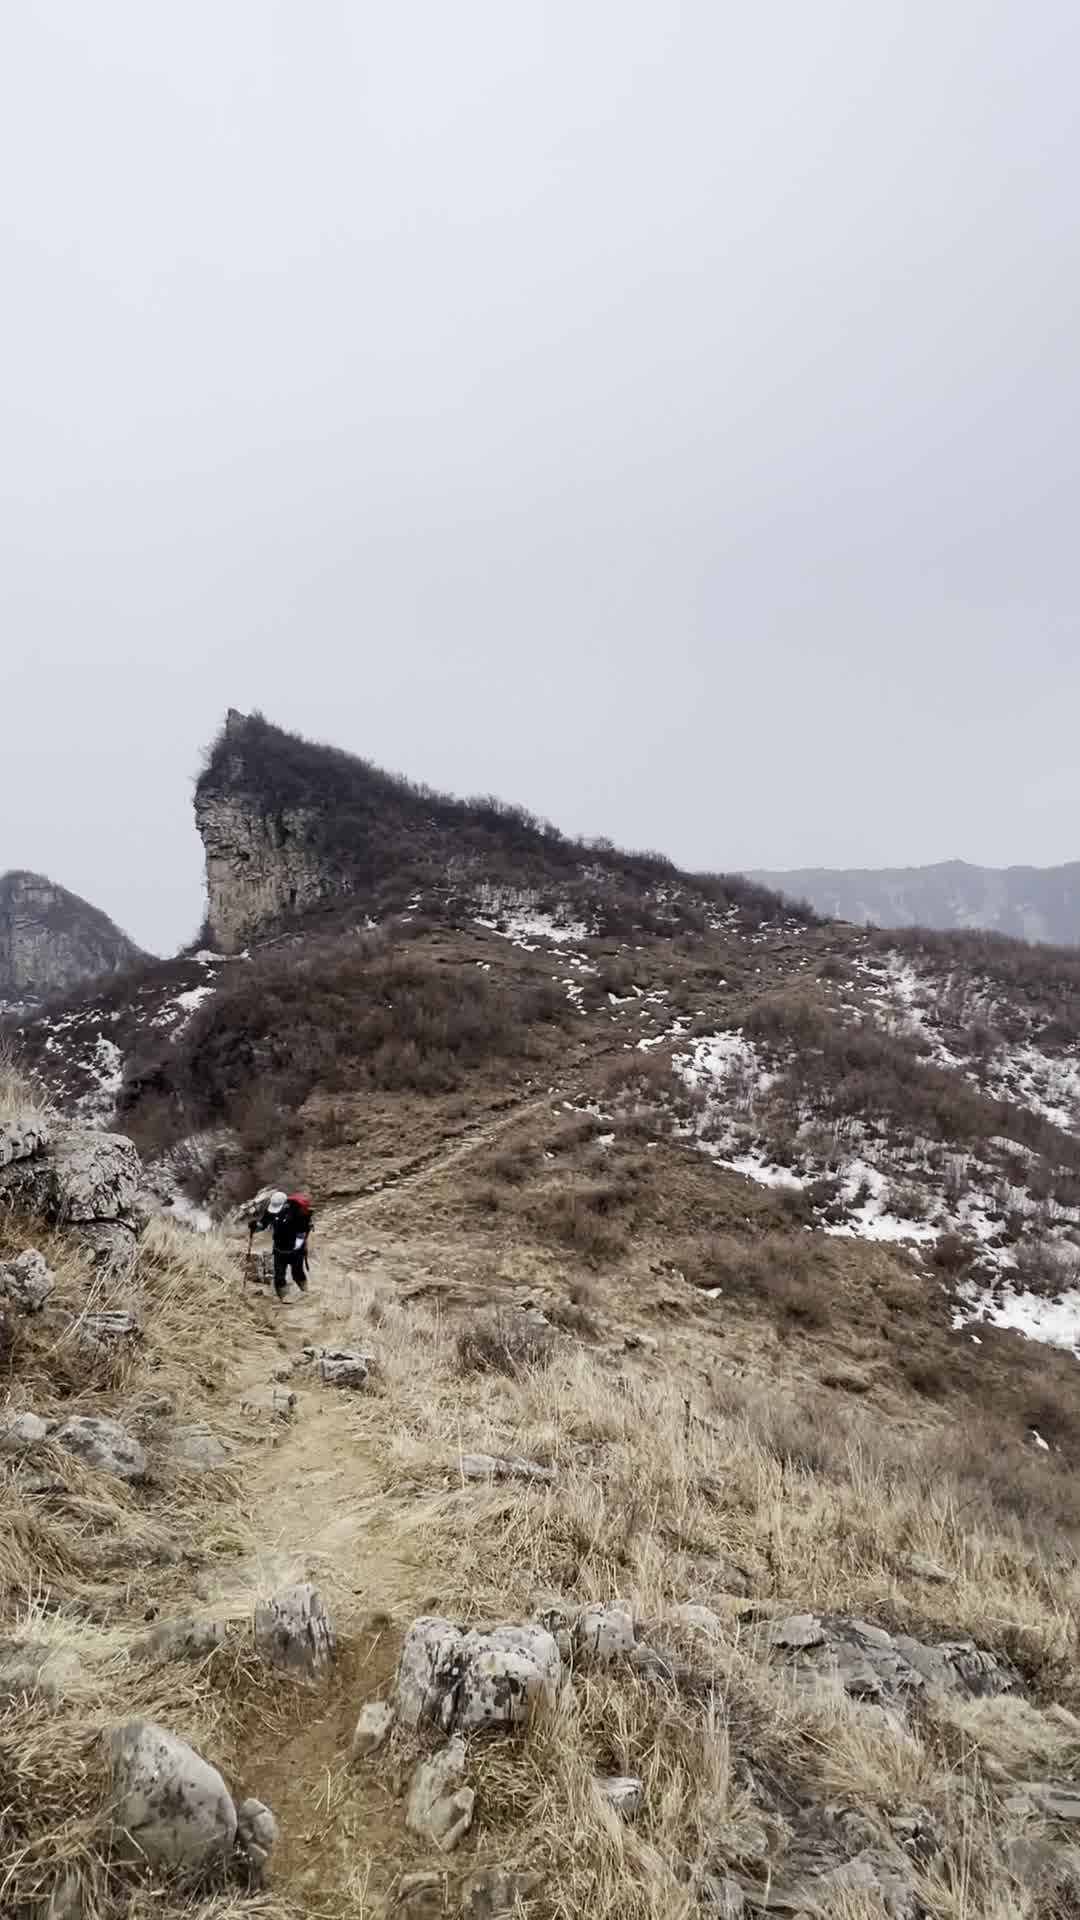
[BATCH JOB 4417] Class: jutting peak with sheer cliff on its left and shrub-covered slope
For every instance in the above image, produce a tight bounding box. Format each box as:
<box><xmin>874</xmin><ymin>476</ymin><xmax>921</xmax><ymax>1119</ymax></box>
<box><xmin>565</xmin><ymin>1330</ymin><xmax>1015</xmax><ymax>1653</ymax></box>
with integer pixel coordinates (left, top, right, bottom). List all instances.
<box><xmin>196</xmin><ymin>712</ymin><xmax>780</xmax><ymax>952</ymax></box>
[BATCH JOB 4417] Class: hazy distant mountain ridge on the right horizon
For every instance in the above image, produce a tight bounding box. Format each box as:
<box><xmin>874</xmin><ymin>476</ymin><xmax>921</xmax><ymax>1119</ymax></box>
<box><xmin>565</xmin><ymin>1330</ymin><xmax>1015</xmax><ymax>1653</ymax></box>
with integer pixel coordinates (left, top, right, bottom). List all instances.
<box><xmin>748</xmin><ymin>860</ymin><xmax>1080</xmax><ymax>947</ymax></box>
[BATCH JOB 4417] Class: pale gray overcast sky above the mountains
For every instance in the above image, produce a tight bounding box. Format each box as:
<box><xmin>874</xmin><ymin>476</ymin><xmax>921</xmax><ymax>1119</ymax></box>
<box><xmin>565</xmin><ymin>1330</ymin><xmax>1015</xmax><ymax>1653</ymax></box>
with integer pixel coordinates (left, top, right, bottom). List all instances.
<box><xmin>0</xmin><ymin>0</ymin><xmax>1080</xmax><ymax>948</ymax></box>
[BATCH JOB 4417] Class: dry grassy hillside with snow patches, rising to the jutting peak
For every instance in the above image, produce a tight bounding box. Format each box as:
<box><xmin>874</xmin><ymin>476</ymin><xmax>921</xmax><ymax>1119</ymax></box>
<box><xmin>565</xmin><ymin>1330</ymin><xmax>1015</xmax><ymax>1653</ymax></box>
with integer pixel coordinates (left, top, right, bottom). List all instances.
<box><xmin>0</xmin><ymin>722</ymin><xmax>1080</xmax><ymax>1920</ymax></box>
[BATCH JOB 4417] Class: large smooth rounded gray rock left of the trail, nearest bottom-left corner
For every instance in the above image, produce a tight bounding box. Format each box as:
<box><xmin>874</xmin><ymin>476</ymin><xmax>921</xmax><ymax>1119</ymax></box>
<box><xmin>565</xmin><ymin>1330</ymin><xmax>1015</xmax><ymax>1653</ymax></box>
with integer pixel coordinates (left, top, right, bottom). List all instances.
<box><xmin>108</xmin><ymin>1720</ymin><xmax>236</xmax><ymax>1878</ymax></box>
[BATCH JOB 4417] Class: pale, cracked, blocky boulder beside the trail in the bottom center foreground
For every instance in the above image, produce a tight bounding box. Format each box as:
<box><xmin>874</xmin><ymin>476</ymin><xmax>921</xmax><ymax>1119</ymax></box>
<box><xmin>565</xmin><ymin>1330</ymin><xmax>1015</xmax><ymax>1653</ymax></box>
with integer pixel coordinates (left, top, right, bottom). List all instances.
<box><xmin>394</xmin><ymin>1617</ymin><xmax>563</xmax><ymax>1732</ymax></box>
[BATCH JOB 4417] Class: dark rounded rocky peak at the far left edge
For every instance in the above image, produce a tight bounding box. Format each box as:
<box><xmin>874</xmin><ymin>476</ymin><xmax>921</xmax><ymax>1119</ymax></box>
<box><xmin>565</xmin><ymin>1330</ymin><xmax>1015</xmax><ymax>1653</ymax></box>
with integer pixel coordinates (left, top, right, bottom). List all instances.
<box><xmin>0</xmin><ymin>872</ymin><xmax>140</xmax><ymax>1002</ymax></box>
